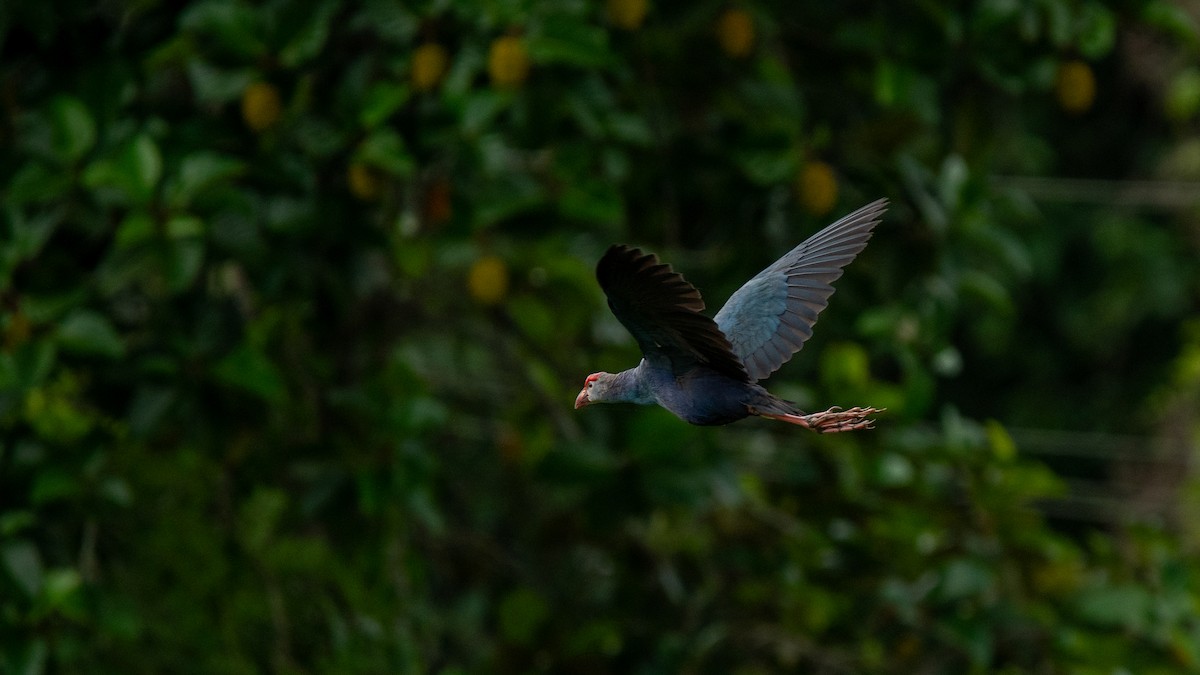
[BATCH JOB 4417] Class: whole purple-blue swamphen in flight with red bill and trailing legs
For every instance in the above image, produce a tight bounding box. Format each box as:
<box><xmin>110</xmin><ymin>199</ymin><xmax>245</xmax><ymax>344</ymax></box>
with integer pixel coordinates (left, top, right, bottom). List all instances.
<box><xmin>575</xmin><ymin>199</ymin><xmax>888</xmax><ymax>432</ymax></box>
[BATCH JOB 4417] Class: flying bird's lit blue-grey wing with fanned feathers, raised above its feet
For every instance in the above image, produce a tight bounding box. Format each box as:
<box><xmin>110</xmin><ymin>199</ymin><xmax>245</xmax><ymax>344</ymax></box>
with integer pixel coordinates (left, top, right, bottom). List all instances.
<box><xmin>715</xmin><ymin>199</ymin><xmax>888</xmax><ymax>381</ymax></box>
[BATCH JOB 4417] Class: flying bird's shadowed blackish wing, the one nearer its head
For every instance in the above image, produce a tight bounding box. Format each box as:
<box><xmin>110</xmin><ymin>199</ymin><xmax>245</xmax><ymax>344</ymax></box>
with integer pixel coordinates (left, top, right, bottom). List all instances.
<box><xmin>596</xmin><ymin>245</ymin><xmax>749</xmax><ymax>382</ymax></box>
